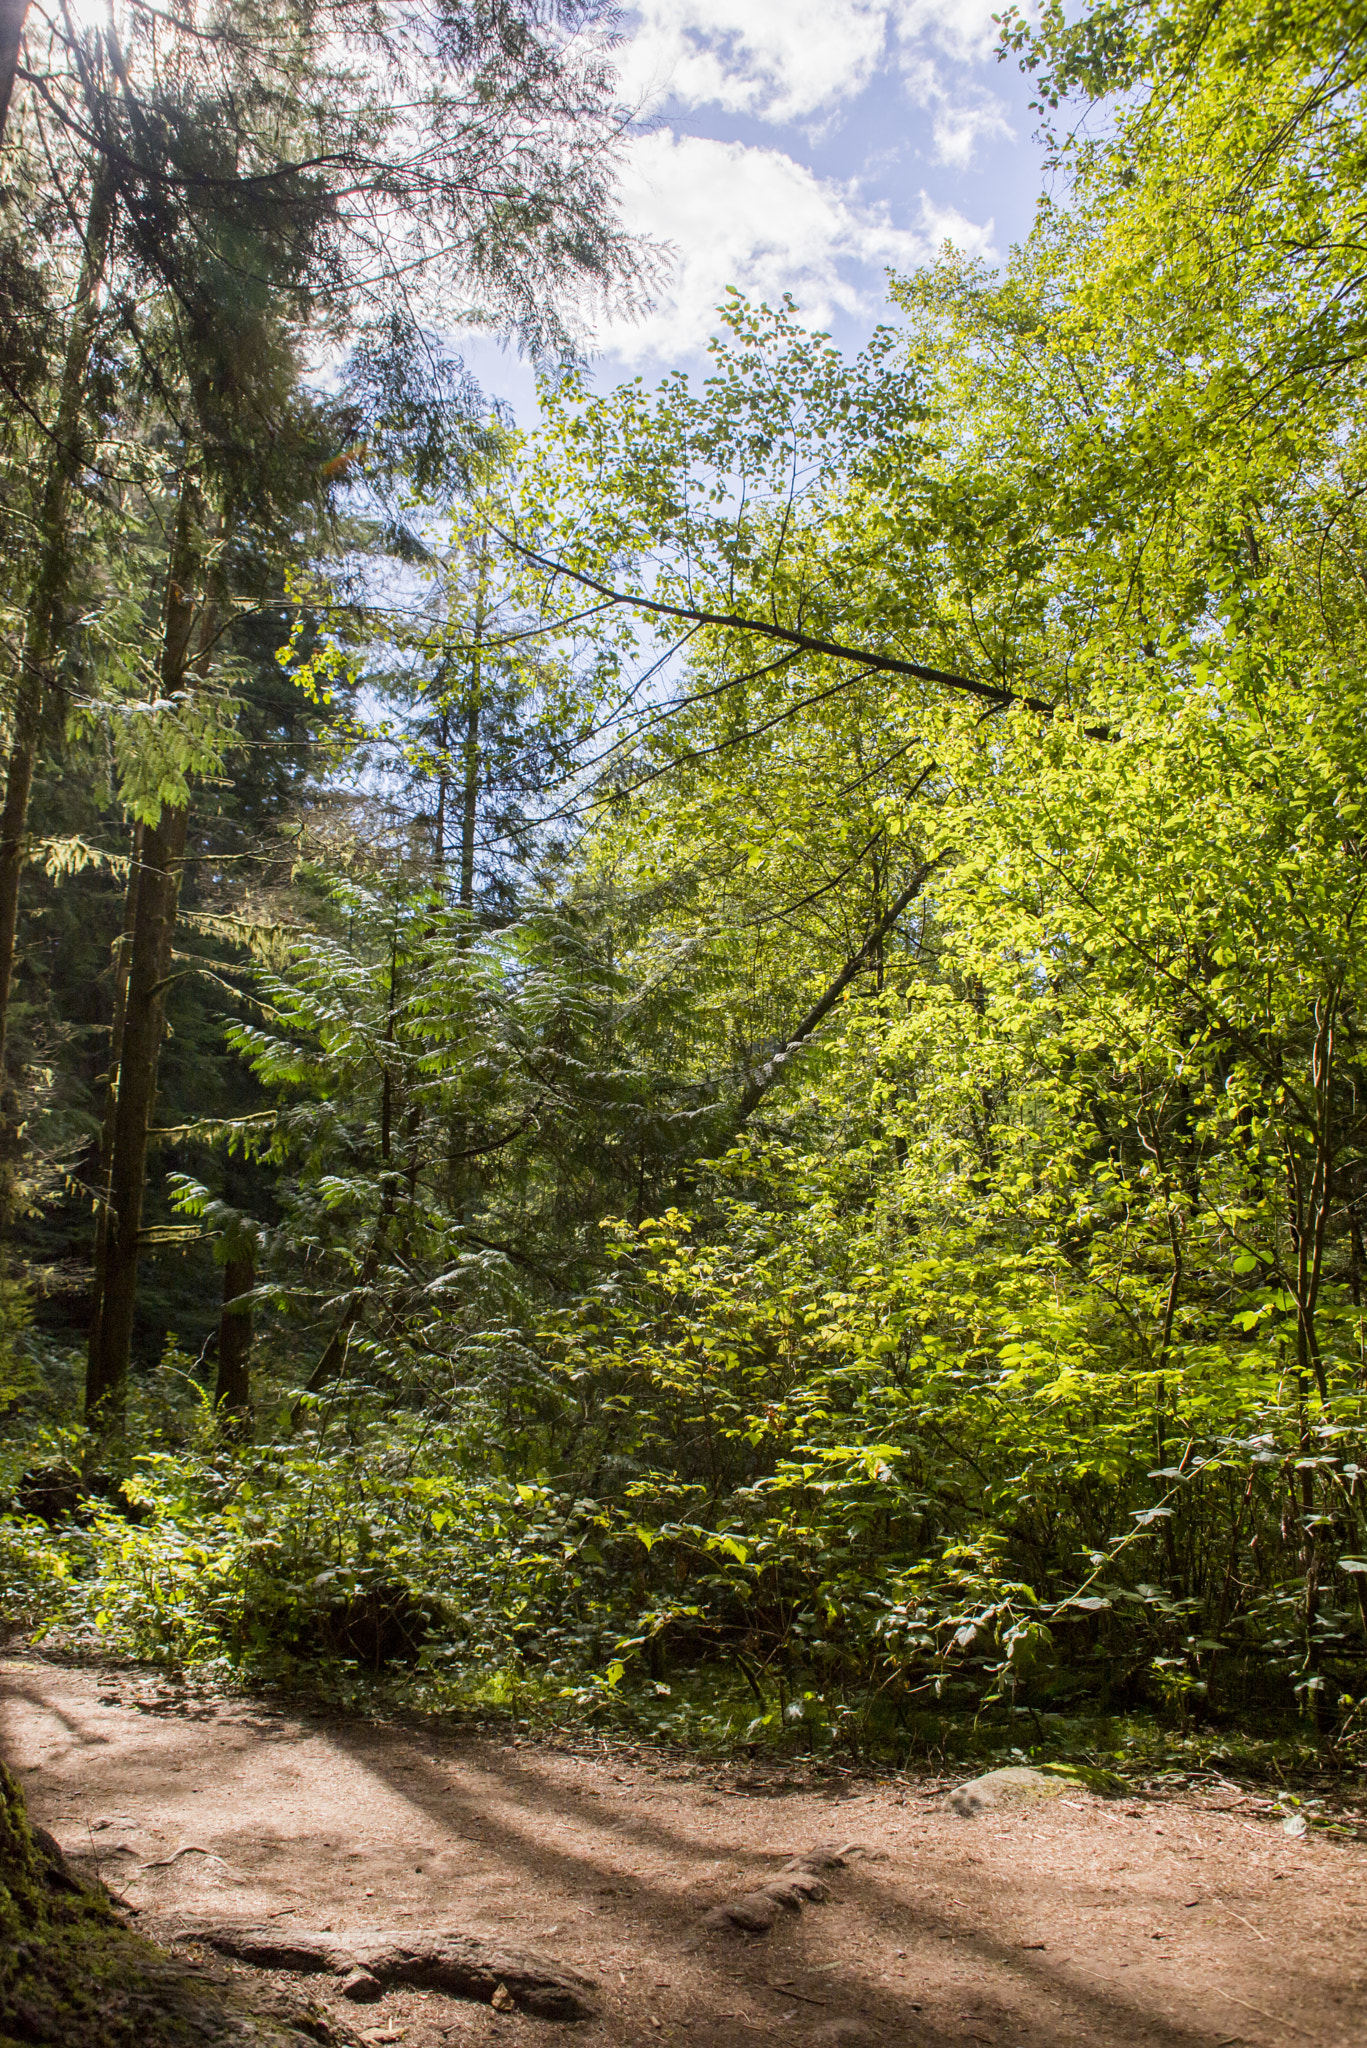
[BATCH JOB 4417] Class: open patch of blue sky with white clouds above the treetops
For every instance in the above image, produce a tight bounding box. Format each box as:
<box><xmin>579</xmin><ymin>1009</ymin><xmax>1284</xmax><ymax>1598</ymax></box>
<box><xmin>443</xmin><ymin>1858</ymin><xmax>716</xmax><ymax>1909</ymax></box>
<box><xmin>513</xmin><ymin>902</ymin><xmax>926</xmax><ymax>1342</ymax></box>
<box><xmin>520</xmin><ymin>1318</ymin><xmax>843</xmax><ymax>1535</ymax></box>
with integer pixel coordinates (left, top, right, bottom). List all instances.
<box><xmin>469</xmin><ymin>0</ymin><xmax>1039</xmax><ymax>420</ymax></box>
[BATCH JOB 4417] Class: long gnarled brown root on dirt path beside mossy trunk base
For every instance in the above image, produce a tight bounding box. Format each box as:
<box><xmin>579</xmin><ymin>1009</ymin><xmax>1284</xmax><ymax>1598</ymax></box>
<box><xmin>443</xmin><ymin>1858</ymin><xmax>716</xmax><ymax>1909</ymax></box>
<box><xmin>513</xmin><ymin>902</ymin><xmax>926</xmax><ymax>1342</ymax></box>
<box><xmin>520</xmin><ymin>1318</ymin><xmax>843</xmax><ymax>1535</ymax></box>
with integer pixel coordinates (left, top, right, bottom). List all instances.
<box><xmin>184</xmin><ymin>1921</ymin><xmax>592</xmax><ymax>2019</ymax></box>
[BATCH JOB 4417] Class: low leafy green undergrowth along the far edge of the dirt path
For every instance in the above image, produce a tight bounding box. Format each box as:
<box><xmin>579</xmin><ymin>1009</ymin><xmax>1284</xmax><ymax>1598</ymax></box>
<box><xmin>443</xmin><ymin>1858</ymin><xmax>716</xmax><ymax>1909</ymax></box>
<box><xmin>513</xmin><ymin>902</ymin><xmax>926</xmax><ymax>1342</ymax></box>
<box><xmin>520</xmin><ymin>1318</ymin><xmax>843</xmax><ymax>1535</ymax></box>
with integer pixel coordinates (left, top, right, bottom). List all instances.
<box><xmin>0</xmin><ymin>1327</ymin><xmax>1367</xmax><ymax>1786</ymax></box>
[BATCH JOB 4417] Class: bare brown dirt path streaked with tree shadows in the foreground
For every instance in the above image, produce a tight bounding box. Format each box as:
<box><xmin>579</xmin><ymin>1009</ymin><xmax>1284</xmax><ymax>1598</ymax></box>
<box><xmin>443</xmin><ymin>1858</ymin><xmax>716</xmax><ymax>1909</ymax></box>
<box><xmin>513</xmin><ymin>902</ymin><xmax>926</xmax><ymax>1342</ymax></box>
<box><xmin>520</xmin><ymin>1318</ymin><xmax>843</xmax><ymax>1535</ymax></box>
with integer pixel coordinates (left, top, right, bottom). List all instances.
<box><xmin>0</xmin><ymin>1657</ymin><xmax>1367</xmax><ymax>2048</ymax></box>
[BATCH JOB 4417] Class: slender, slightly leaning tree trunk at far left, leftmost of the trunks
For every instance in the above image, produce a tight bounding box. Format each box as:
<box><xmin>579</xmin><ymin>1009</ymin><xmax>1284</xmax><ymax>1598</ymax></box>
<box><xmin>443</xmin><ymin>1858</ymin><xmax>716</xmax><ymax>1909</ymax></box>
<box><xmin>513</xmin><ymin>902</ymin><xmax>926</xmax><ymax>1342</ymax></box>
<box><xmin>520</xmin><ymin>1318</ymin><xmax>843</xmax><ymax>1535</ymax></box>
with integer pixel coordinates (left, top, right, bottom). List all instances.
<box><xmin>0</xmin><ymin>163</ymin><xmax>113</xmax><ymax>1138</ymax></box>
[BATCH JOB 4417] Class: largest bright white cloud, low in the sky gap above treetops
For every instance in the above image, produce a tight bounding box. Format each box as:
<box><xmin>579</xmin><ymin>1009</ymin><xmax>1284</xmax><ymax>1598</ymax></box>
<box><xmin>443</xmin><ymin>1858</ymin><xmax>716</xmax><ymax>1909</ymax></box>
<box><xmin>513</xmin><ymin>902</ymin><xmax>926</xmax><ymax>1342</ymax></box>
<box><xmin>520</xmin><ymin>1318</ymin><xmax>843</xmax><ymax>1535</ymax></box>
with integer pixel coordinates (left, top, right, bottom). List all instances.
<box><xmin>598</xmin><ymin>131</ymin><xmax>992</xmax><ymax>365</ymax></box>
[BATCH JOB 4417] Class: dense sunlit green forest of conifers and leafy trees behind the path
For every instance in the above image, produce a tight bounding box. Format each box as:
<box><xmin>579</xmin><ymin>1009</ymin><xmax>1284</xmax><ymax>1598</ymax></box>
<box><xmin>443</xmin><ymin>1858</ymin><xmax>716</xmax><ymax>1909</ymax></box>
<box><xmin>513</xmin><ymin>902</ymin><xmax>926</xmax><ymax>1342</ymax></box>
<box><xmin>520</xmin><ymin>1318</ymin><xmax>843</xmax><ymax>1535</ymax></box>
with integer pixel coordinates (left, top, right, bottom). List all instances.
<box><xmin>0</xmin><ymin>0</ymin><xmax>1367</xmax><ymax>1759</ymax></box>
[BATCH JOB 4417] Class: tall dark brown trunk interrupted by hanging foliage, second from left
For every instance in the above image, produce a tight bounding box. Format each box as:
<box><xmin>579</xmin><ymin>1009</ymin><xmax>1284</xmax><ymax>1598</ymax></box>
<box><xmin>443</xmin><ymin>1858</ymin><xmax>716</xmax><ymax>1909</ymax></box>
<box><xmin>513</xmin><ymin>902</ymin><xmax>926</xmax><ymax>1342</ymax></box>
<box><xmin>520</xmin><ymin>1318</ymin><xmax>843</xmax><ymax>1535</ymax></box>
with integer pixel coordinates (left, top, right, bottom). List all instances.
<box><xmin>86</xmin><ymin>477</ymin><xmax>209</xmax><ymax>1430</ymax></box>
